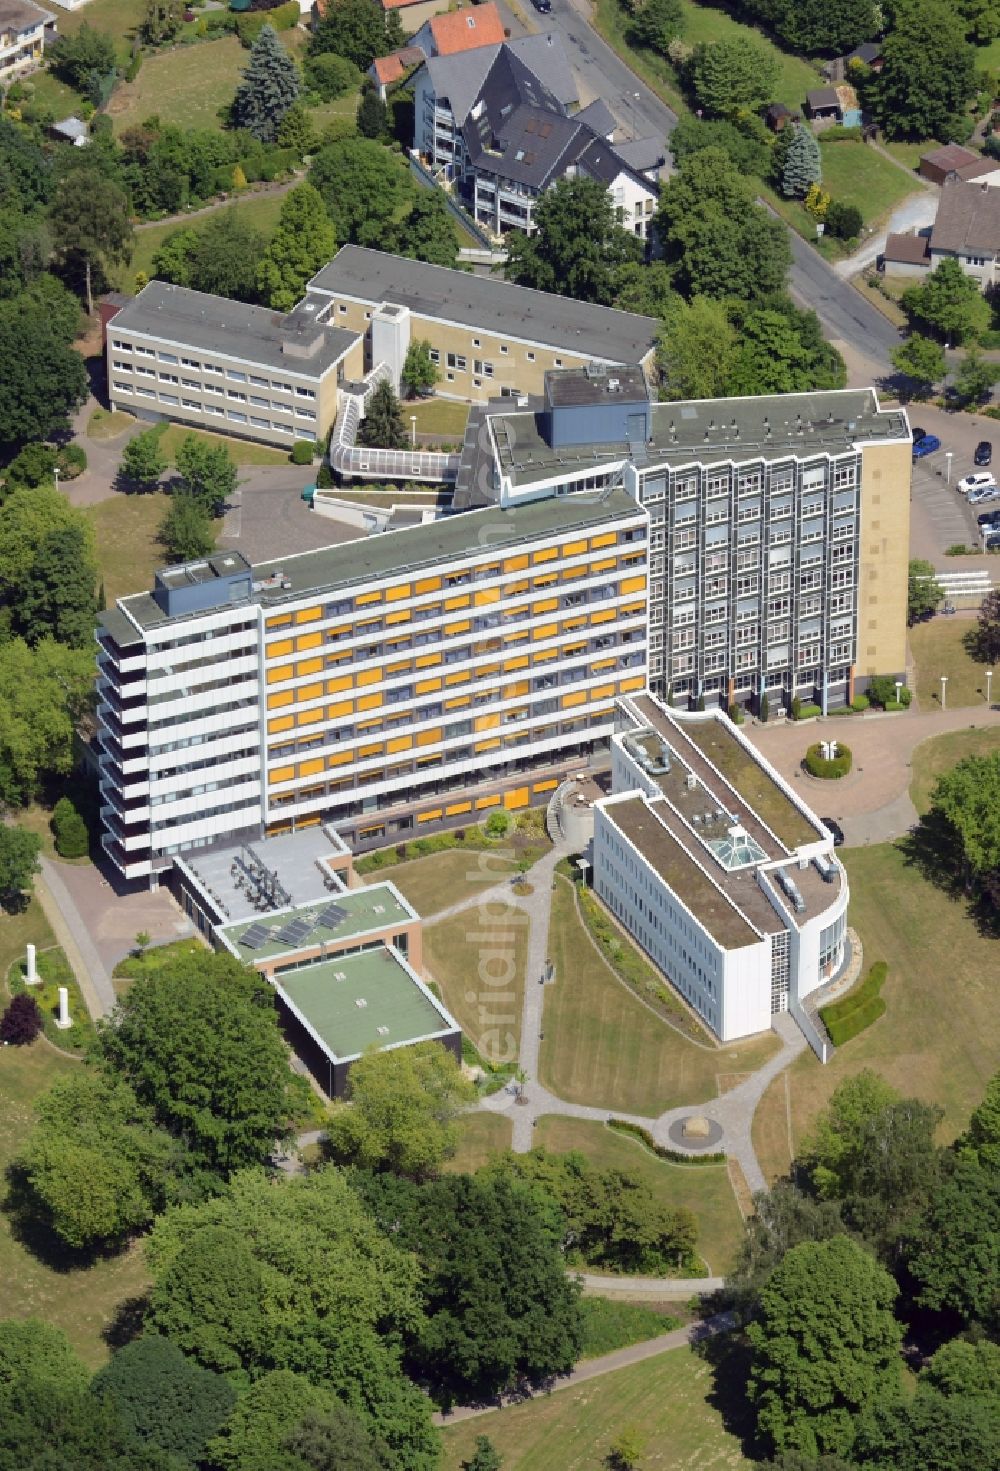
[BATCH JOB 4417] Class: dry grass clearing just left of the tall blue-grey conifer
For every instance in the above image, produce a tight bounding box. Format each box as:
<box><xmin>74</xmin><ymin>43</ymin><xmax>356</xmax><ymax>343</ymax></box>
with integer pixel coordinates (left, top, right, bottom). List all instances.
<box><xmin>105</xmin><ymin>35</ymin><xmax>247</xmax><ymax>134</ymax></box>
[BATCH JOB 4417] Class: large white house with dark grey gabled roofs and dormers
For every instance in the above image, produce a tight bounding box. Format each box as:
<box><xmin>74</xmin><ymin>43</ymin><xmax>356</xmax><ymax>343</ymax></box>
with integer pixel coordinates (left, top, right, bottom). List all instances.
<box><xmin>413</xmin><ymin>35</ymin><xmax>657</xmax><ymax>240</ymax></box>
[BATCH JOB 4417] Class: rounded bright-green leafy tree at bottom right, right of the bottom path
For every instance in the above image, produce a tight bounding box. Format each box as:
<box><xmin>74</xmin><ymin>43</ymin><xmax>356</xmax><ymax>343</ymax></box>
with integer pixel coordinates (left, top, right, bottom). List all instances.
<box><xmin>747</xmin><ymin>1236</ymin><xmax>903</xmax><ymax>1456</ymax></box>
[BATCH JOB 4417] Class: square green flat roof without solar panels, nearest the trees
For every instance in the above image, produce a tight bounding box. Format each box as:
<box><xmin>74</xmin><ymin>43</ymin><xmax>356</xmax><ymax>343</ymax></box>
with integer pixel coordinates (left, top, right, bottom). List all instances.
<box><xmin>276</xmin><ymin>946</ymin><xmax>457</xmax><ymax>1062</ymax></box>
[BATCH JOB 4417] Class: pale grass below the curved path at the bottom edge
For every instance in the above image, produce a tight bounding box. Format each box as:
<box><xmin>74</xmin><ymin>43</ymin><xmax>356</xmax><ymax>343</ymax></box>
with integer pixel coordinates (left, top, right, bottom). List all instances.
<box><xmin>443</xmin><ymin>1349</ymin><xmax>751</xmax><ymax>1471</ymax></box>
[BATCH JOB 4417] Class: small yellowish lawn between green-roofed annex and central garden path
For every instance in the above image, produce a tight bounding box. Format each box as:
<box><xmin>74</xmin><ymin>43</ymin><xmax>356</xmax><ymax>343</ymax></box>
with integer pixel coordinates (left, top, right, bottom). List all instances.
<box><xmin>424</xmin><ymin>906</ymin><xmax>528</xmax><ymax>1062</ymax></box>
